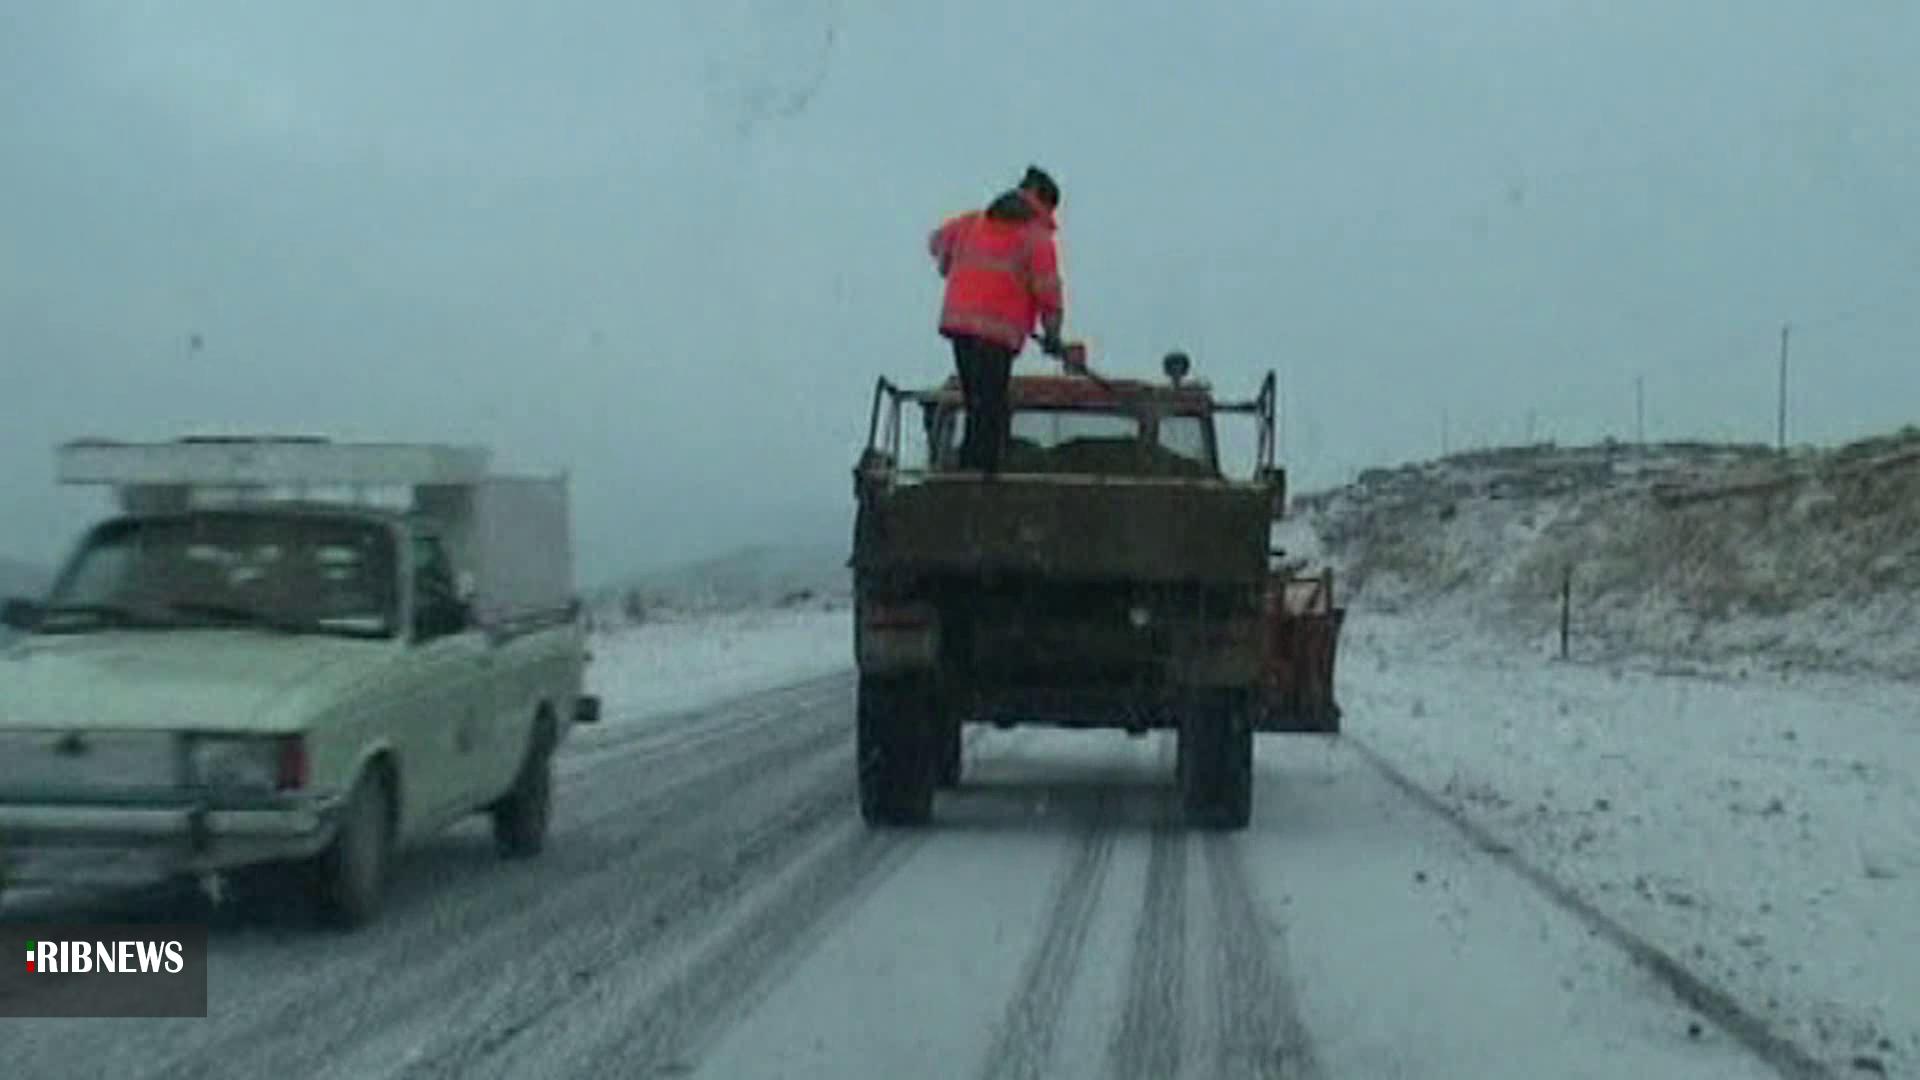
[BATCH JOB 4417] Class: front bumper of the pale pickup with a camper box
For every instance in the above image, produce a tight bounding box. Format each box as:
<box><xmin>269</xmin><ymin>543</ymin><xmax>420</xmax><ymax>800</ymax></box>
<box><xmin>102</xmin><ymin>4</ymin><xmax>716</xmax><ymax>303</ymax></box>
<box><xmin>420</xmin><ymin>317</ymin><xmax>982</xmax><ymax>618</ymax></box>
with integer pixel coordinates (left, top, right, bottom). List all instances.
<box><xmin>0</xmin><ymin>798</ymin><xmax>338</xmax><ymax>886</ymax></box>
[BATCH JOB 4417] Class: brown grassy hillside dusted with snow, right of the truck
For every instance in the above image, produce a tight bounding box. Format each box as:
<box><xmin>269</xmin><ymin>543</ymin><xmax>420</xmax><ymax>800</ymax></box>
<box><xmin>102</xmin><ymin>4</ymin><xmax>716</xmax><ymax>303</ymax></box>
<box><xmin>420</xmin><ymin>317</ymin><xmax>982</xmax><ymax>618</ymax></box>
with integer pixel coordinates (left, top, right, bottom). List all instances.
<box><xmin>1296</xmin><ymin>429</ymin><xmax>1920</xmax><ymax>676</ymax></box>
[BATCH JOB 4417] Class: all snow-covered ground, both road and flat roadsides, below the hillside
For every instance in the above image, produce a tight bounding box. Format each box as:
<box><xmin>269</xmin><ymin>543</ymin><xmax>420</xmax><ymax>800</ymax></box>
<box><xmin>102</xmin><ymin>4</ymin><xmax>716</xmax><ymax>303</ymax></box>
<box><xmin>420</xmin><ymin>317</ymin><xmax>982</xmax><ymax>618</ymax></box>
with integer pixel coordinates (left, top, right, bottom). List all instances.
<box><xmin>6</xmin><ymin>595</ymin><xmax>1920</xmax><ymax>1080</ymax></box>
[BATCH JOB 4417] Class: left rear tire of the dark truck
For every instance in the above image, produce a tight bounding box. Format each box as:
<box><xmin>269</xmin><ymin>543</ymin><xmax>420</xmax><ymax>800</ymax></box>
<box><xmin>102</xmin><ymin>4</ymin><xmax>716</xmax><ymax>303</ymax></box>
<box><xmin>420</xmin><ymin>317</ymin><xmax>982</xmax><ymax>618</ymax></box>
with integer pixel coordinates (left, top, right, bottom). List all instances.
<box><xmin>854</xmin><ymin>676</ymin><xmax>941</xmax><ymax>826</ymax></box>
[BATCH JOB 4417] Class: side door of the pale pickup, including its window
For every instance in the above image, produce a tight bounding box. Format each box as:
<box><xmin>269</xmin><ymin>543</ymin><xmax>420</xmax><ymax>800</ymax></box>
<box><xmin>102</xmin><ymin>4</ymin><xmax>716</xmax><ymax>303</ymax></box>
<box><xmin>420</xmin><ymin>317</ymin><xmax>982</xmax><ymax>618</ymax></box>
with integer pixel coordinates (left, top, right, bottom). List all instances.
<box><xmin>409</xmin><ymin>536</ymin><xmax>499</xmax><ymax>822</ymax></box>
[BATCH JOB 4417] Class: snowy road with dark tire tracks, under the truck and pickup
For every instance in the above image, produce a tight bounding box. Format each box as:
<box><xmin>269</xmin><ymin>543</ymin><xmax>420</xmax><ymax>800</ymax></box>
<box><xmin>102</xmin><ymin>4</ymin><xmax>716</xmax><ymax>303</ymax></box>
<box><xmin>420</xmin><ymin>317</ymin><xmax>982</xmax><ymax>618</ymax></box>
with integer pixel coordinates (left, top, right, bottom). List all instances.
<box><xmin>0</xmin><ymin>675</ymin><xmax>1827</xmax><ymax>1080</ymax></box>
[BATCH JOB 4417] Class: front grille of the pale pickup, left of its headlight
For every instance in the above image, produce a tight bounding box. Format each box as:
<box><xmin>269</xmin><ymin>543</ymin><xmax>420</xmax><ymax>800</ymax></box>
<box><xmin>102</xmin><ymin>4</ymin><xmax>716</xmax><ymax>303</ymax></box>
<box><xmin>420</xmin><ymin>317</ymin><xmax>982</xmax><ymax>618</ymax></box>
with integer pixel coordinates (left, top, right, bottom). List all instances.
<box><xmin>0</xmin><ymin>730</ymin><xmax>180</xmax><ymax>799</ymax></box>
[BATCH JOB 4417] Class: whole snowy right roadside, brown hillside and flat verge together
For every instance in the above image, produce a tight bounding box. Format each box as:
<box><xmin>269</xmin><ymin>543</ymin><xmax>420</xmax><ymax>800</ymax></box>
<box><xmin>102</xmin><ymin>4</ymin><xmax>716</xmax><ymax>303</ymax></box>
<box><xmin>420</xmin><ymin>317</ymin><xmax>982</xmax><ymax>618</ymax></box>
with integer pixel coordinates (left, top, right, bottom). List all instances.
<box><xmin>1275</xmin><ymin>429</ymin><xmax>1920</xmax><ymax>1072</ymax></box>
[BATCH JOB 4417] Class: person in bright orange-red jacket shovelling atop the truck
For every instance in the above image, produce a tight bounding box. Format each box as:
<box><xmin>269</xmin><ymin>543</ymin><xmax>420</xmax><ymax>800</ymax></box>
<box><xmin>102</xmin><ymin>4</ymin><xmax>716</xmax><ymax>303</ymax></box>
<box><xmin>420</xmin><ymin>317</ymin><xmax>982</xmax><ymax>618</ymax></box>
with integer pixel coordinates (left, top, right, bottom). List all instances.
<box><xmin>927</xmin><ymin>165</ymin><xmax>1066</xmax><ymax>475</ymax></box>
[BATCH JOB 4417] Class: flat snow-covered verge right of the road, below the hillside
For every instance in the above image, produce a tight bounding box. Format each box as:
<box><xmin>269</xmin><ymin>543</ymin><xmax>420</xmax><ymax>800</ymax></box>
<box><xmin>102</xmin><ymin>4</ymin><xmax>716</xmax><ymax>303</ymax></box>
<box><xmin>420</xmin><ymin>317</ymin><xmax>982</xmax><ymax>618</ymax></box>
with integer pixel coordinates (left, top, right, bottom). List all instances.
<box><xmin>1340</xmin><ymin>613</ymin><xmax>1920</xmax><ymax>1074</ymax></box>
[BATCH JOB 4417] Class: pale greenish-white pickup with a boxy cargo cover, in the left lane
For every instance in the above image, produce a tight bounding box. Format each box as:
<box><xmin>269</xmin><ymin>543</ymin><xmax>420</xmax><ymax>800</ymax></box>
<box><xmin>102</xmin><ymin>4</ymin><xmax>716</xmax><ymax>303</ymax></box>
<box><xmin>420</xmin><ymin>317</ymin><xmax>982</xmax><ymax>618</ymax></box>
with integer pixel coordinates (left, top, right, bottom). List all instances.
<box><xmin>0</xmin><ymin>438</ymin><xmax>599</xmax><ymax>926</ymax></box>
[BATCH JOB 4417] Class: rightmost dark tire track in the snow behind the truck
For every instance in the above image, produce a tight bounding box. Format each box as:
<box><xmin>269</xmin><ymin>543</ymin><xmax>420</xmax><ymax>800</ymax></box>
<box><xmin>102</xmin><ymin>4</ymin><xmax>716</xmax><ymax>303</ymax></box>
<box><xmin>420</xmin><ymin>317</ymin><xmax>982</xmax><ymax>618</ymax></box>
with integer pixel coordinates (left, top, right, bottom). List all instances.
<box><xmin>1204</xmin><ymin>834</ymin><xmax>1321</xmax><ymax>1080</ymax></box>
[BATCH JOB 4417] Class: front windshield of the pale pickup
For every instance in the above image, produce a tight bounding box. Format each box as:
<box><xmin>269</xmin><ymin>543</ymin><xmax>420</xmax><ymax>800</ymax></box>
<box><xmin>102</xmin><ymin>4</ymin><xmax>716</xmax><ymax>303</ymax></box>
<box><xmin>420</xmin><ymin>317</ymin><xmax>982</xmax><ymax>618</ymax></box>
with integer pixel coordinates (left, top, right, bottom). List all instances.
<box><xmin>40</xmin><ymin>513</ymin><xmax>397</xmax><ymax>638</ymax></box>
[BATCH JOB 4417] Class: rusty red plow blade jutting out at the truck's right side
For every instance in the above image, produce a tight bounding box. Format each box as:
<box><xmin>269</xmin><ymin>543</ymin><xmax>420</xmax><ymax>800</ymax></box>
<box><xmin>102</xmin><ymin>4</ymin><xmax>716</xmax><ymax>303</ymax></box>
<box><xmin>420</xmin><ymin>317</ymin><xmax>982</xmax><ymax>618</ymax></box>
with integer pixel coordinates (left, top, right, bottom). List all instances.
<box><xmin>1256</xmin><ymin>571</ymin><xmax>1346</xmax><ymax>734</ymax></box>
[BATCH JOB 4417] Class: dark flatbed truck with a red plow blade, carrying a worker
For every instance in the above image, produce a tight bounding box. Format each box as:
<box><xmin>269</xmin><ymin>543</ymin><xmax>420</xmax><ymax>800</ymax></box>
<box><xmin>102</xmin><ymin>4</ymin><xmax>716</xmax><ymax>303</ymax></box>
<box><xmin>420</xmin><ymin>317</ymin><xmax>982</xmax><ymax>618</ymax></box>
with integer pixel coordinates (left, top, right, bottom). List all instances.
<box><xmin>849</xmin><ymin>352</ymin><xmax>1346</xmax><ymax>828</ymax></box>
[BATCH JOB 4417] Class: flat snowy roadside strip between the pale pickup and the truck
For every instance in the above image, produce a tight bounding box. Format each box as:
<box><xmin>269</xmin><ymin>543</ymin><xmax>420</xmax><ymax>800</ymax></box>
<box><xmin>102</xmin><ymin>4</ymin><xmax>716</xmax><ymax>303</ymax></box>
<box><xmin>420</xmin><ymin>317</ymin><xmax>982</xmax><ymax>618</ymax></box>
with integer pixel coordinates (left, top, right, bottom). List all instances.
<box><xmin>588</xmin><ymin>607</ymin><xmax>852</xmax><ymax>723</ymax></box>
